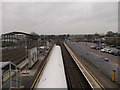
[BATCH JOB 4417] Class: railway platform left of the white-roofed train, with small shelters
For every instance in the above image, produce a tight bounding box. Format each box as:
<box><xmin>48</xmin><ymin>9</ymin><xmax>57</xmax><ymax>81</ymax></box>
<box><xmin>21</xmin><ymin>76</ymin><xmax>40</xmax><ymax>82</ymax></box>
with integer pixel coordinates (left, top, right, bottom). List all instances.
<box><xmin>3</xmin><ymin>44</ymin><xmax>50</xmax><ymax>90</ymax></box>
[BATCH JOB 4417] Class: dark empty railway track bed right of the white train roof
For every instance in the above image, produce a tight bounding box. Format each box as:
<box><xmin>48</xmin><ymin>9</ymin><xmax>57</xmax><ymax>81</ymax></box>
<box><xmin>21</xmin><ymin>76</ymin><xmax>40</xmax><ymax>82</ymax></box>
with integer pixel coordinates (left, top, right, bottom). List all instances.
<box><xmin>61</xmin><ymin>44</ymin><xmax>92</xmax><ymax>90</ymax></box>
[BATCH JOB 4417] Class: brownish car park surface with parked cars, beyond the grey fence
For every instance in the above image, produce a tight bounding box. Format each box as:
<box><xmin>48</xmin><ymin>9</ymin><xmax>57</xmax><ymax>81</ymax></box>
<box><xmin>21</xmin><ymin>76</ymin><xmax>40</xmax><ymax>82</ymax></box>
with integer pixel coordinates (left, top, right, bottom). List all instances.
<box><xmin>77</xmin><ymin>42</ymin><xmax>118</xmax><ymax>63</ymax></box>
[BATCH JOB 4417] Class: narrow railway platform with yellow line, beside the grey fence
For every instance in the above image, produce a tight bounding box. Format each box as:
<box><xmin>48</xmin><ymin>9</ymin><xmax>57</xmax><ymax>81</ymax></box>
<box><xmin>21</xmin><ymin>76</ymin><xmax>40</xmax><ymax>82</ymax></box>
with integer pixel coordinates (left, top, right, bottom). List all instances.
<box><xmin>65</xmin><ymin>44</ymin><xmax>120</xmax><ymax>90</ymax></box>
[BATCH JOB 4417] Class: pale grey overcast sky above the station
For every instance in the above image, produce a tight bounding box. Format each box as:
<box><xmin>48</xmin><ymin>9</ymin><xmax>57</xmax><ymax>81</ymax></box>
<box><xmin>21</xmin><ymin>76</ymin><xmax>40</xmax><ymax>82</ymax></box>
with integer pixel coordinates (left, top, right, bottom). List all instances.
<box><xmin>2</xmin><ymin>2</ymin><xmax>118</xmax><ymax>34</ymax></box>
